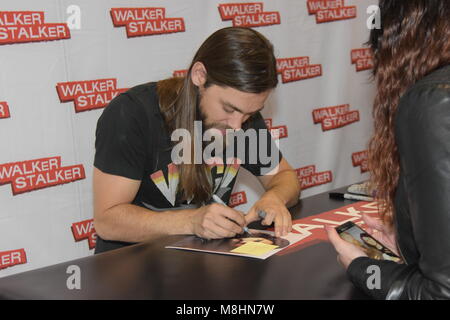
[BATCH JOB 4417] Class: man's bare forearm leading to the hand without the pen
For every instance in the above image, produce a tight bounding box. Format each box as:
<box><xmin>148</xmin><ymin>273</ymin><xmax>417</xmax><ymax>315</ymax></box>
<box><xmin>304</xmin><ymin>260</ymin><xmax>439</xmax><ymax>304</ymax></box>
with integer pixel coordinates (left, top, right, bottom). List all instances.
<box><xmin>266</xmin><ymin>170</ymin><xmax>300</xmax><ymax>208</ymax></box>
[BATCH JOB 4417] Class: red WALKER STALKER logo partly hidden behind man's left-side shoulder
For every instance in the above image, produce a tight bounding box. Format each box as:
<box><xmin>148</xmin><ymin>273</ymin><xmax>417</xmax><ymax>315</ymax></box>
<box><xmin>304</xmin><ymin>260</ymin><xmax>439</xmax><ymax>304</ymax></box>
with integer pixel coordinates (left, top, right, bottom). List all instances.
<box><xmin>56</xmin><ymin>78</ymin><xmax>128</xmax><ymax>113</ymax></box>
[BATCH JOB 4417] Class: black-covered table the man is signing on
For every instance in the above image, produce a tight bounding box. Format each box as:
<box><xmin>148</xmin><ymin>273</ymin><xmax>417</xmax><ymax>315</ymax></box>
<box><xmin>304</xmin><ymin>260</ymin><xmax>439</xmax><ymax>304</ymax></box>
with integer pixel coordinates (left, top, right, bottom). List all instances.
<box><xmin>0</xmin><ymin>188</ymin><xmax>368</xmax><ymax>300</ymax></box>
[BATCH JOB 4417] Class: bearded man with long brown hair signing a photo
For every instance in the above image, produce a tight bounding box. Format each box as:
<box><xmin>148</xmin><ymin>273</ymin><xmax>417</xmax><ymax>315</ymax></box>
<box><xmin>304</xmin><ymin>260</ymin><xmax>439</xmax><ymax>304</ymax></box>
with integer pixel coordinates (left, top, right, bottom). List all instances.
<box><xmin>94</xmin><ymin>28</ymin><xmax>300</xmax><ymax>253</ymax></box>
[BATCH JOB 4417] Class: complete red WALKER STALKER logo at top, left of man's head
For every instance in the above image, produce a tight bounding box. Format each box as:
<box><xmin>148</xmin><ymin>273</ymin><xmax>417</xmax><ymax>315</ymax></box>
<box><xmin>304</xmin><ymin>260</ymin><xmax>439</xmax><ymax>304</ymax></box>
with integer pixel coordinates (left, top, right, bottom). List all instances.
<box><xmin>111</xmin><ymin>8</ymin><xmax>186</xmax><ymax>38</ymax></box>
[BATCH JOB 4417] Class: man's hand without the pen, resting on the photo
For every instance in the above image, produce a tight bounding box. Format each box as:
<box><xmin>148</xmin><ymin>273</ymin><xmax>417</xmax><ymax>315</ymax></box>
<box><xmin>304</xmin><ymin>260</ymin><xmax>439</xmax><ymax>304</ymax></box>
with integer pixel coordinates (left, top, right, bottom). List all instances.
<box><xmin>245</xmin><ymin>192</ymin><xmax>292</xmax><ymax>237</ymax></box>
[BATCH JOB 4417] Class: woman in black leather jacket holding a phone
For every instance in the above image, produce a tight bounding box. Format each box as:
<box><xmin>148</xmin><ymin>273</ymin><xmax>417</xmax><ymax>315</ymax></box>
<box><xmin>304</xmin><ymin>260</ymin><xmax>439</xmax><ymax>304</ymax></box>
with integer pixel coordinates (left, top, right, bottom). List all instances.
<box><xmin>327</xmin><ymin>0</ymin><xmax>450</xmax><ymax>299</ymax></box>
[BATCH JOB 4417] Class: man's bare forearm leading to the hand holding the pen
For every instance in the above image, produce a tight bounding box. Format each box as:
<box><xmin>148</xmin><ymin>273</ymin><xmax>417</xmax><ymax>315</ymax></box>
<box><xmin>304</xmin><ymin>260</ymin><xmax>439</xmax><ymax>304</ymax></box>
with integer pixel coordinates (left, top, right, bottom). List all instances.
<box><xmin>94</xmin><ymin>204</ymin><xmax>195</xmax><ymax>242</ymax></box>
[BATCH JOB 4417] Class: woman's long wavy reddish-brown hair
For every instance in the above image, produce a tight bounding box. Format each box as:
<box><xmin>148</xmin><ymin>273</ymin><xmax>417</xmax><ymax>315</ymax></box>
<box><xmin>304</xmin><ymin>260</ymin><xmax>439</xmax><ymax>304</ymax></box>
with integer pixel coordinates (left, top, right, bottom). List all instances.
<box><xmin>369</xmin><ymin>0</ymin><xmax>450</xmax><ymax>224</ymax></box>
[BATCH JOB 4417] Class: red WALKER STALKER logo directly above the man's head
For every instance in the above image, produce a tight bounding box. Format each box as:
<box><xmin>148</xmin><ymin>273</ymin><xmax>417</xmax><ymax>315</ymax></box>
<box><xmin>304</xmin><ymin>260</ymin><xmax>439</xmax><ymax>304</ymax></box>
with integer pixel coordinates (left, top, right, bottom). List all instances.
<box><xmin>219</xmin><ymin>2</ymin><xmax>281</xmax><ymax>27</ymax></box>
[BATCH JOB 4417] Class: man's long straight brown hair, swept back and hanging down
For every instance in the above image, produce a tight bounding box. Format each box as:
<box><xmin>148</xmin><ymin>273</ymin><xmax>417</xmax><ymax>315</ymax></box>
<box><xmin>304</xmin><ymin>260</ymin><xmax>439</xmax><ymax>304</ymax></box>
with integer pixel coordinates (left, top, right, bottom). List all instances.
<box><xmin>158</xmin><ymin>27</ymin><xmax>278</xmax><ymax>205</ymax></box>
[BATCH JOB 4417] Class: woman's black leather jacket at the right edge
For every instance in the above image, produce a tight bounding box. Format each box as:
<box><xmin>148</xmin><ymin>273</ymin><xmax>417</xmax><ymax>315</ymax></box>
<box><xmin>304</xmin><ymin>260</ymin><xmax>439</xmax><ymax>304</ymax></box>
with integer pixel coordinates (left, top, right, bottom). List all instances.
<box><xmin>347</xmin><ymin>66</ymin><xmax>450</xmax><ymax>300</ymax></box>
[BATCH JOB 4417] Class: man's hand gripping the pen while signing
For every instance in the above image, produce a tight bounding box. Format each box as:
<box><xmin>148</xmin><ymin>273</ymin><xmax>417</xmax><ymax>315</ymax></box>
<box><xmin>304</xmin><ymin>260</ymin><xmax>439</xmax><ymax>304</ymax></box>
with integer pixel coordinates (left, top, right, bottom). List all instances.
<box><xmin>192</xmin><ymin>203</ymin><xmax>246</xmax><ymax>239</ymax></box>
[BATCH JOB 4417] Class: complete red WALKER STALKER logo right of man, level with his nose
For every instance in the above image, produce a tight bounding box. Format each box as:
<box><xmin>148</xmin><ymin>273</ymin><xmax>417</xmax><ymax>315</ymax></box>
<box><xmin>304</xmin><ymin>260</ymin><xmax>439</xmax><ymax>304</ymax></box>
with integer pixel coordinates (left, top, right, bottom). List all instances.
<box><xmin>312</xmin><ymin>104</ymin><xmax>359</xmax><ymax>131</ymax></box>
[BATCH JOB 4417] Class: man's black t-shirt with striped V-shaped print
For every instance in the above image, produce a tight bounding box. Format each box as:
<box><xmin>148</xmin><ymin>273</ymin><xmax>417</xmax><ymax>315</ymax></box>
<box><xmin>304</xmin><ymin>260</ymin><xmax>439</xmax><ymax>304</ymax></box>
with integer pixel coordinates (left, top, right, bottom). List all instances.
<box><xmin>94</xmin><ymin>82</ymin><xmax>282</xmax><ymax>253</ymax></box>
